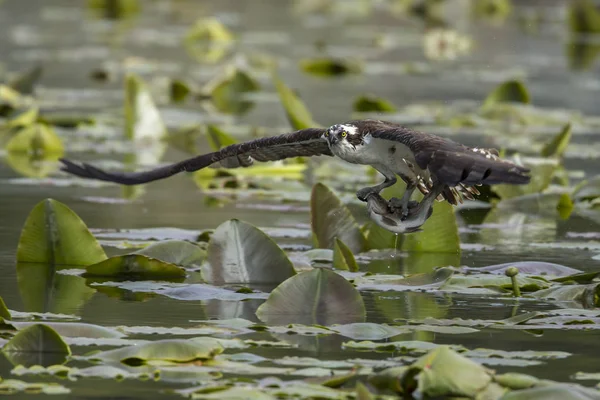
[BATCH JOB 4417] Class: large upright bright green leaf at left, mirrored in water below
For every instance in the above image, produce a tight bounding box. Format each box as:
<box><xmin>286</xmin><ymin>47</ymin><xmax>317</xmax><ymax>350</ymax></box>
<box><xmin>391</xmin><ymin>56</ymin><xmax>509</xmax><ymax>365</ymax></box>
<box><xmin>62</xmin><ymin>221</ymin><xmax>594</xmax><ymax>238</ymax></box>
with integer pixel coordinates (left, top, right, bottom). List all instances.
<box><xmin>17</xmin><ymin>199</ymin><xmax>106</xmax><ymax>265</ymax></box>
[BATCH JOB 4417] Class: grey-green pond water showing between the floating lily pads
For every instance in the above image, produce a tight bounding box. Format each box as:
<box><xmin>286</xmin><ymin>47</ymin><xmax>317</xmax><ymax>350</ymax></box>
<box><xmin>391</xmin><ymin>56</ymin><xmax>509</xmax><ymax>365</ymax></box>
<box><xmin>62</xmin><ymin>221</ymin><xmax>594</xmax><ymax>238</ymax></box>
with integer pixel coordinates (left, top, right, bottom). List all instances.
<box><xmin>0</xmin><ymin>0</ymin><xmax>600</xmax><ymax>398</ymax></box>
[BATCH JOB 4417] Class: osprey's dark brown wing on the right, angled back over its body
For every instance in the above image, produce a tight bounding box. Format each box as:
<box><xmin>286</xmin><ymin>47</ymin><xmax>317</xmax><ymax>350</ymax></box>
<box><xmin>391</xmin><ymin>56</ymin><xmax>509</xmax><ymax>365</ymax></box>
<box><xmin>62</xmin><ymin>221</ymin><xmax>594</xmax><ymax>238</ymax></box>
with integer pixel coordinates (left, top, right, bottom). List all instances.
<box><xmin>354</xmin><ymin>121</ymin><xmax>530</xmax><ymax>187</ymax></box>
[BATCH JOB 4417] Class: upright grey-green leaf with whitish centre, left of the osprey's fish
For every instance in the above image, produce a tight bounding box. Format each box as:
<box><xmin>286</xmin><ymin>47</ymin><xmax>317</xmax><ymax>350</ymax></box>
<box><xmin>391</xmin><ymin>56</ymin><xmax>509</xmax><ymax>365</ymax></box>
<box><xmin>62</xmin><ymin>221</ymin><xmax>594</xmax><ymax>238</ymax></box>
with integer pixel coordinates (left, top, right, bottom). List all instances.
<box><xmin>202</xmin><ymin>219</ymin><xmax>296</xmax><ymax>284</ymax></box>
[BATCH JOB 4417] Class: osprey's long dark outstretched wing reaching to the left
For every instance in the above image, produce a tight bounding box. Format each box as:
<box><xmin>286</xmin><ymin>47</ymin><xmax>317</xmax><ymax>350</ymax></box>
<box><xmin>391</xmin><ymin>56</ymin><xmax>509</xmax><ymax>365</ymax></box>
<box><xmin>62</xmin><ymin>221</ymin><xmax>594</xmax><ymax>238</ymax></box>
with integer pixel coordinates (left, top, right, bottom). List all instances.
<box><xmin>60</xmin><ymin>128</ymin><xmax>332</xmax><ymax>185</ymax></box>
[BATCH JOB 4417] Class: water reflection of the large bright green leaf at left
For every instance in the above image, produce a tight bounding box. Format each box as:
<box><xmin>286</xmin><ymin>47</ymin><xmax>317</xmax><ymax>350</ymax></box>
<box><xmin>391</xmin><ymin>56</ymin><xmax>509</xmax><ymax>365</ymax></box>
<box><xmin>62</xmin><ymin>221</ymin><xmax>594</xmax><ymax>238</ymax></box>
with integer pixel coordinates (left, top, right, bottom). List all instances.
<box><xmin>17</xmin><ymin>262</ymin><xmax>95</xmax><ymax>314</ymax></box>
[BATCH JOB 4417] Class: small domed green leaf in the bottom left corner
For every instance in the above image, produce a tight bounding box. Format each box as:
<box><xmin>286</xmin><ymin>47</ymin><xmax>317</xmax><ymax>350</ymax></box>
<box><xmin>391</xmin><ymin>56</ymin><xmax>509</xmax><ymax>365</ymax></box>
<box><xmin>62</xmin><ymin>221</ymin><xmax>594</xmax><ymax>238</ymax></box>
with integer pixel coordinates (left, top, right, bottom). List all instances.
<box><xmin>2</xmin><ymin>324</ymin><xmax>71</xmax><ymax>364</ymax></box>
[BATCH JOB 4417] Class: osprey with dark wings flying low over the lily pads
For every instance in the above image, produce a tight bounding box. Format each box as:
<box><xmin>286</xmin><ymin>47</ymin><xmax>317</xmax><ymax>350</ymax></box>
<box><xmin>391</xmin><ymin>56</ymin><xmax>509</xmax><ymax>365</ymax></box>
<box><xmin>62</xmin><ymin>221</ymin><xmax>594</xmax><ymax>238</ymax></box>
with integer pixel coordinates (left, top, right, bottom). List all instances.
<box><xmin>60</xmin><ymin>119</ymin><xmax>530</xmax><ymax>217</ymax></box>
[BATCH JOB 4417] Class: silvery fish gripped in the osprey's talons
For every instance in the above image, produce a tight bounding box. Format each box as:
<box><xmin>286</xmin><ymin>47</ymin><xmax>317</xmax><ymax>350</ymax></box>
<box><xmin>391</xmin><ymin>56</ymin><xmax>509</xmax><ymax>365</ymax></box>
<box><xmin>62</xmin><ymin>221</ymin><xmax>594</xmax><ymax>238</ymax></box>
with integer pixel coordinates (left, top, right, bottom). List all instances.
<box><xmin>367</xmin><ymin>193</ymin><xmax>433</xmax><ymax>233</ymax></box>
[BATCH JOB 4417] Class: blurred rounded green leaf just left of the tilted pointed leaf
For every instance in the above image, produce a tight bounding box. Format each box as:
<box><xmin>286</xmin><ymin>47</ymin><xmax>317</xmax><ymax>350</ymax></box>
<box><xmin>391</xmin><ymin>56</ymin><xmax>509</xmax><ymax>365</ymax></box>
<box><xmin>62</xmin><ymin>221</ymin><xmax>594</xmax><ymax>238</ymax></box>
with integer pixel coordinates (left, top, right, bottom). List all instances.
<box><xmin>203</xmin><ymin>66</ymin><xmax>260</xmax><ymax>114</ymax></box>
